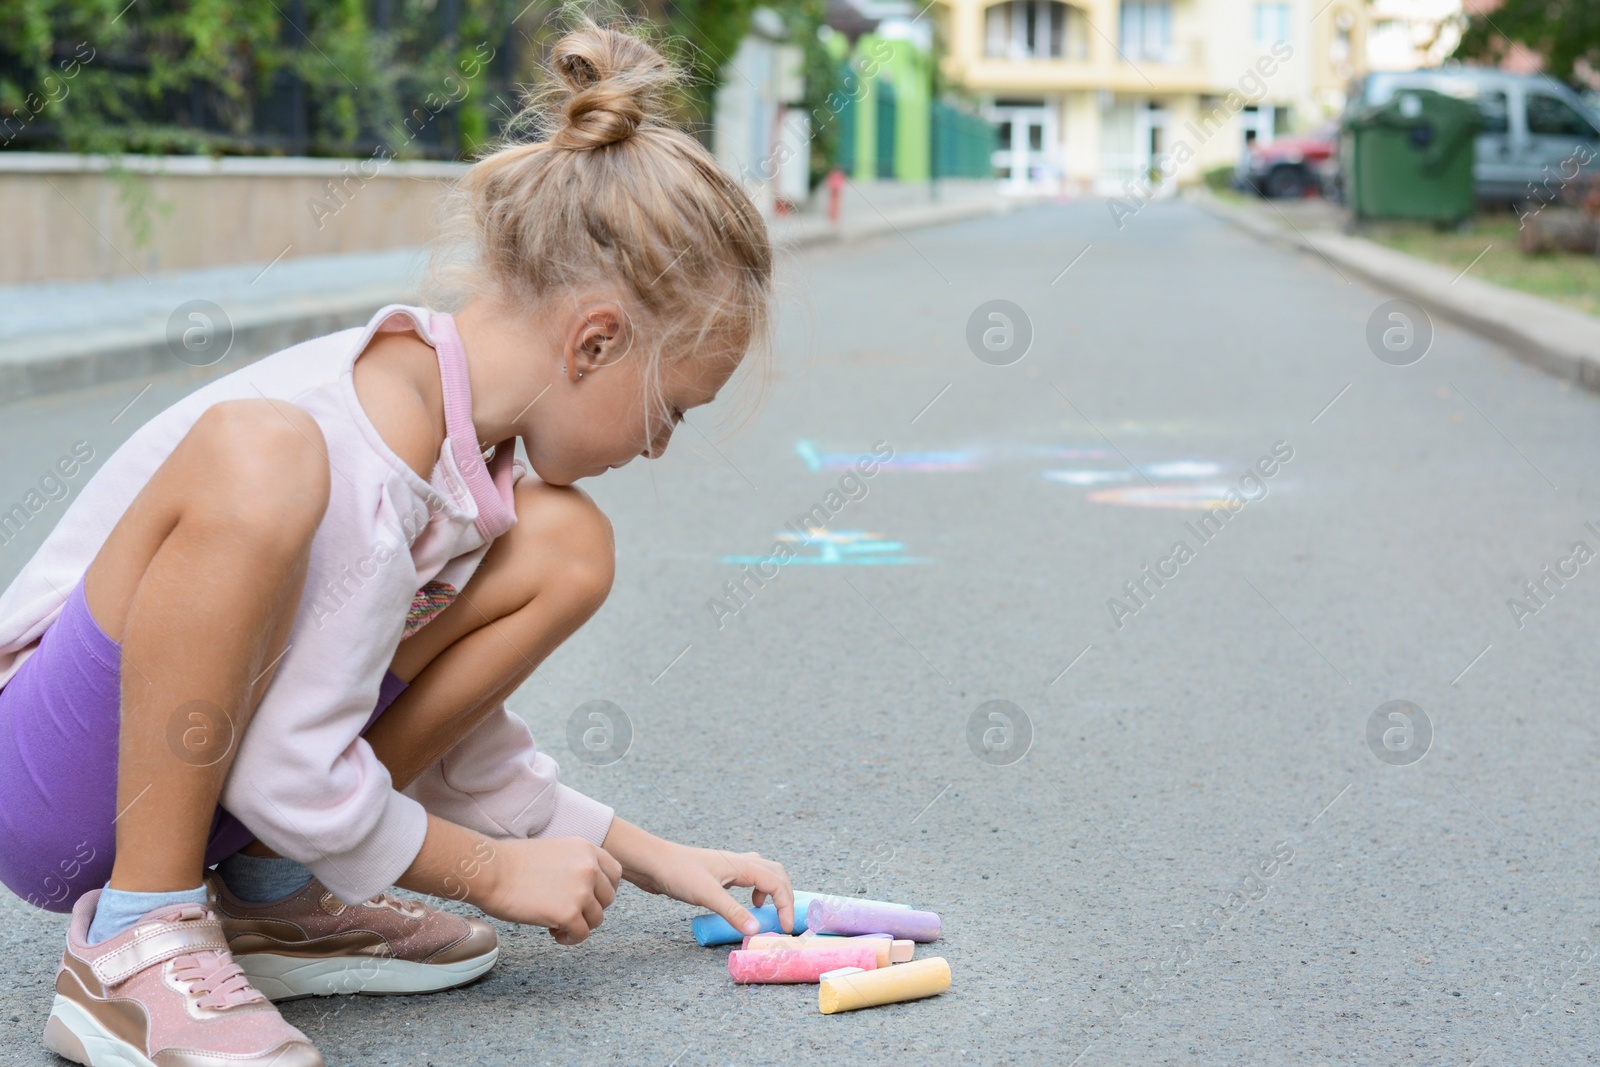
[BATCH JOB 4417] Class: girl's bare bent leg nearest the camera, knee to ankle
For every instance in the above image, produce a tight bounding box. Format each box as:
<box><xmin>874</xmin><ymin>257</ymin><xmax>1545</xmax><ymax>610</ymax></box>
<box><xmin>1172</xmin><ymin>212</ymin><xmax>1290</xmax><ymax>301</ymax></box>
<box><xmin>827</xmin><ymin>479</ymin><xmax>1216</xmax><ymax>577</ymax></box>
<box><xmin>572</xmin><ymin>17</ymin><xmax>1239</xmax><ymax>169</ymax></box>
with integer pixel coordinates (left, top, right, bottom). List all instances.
<box><xmin>83</xmin><ymin>400</ymin><xmax>328</xmax><ymax>893</ymax></box>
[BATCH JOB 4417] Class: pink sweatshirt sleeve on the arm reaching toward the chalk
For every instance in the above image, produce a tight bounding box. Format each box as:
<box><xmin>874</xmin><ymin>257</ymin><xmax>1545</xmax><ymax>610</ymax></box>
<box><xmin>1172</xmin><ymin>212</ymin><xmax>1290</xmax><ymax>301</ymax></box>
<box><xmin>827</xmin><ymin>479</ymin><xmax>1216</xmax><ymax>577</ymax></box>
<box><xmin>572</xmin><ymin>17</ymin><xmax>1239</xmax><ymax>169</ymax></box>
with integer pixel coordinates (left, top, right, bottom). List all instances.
<box><xmin>405</xmin><ymin>704</ymin><xmax>613</xmax><ymax>846</ymax></box>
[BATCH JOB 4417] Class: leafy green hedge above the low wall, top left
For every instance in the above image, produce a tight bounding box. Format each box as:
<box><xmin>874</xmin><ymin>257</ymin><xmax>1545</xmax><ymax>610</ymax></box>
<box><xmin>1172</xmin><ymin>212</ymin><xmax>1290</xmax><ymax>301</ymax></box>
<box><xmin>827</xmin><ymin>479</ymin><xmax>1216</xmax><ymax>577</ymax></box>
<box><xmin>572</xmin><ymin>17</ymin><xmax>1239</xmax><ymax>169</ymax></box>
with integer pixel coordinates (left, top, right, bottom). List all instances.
<box><xmin>0</xmin><ymin>0</ymin><xmax>832</xmax><ymax>158</ymax></box>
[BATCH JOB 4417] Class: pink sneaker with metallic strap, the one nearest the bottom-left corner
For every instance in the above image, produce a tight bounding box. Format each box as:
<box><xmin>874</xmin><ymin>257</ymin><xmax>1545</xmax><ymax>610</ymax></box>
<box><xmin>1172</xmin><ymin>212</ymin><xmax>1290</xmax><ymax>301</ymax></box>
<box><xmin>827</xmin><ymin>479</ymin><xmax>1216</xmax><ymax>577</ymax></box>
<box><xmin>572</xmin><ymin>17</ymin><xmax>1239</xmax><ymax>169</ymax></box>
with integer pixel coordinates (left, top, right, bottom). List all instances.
<box><xmin>45</xmin><ymin>889</ymin><xmax>323</xmax><ymax>1067</ymax></box>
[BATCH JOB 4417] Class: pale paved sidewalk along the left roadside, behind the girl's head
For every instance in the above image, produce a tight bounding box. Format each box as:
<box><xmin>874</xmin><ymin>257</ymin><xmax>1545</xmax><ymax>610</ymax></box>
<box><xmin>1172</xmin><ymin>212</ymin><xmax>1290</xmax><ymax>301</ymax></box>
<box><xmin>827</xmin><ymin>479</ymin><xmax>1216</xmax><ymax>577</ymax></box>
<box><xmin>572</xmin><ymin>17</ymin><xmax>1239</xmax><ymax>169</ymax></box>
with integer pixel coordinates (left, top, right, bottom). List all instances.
<box><xmin>0</xmin><ymin>182</ymin><xmax>1010</xmax><ymax>402</ymax></box>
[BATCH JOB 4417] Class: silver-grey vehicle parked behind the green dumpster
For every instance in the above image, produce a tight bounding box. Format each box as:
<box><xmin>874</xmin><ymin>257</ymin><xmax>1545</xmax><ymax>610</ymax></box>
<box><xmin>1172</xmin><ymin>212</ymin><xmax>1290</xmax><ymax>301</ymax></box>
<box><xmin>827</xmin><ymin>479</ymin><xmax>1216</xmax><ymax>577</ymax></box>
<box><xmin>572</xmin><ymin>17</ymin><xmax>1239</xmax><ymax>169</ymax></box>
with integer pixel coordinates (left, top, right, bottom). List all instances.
<box><xmin>1346</xmin><ymin>67</ymin><xmax>1600</xmax><ymax>203</ymax></box>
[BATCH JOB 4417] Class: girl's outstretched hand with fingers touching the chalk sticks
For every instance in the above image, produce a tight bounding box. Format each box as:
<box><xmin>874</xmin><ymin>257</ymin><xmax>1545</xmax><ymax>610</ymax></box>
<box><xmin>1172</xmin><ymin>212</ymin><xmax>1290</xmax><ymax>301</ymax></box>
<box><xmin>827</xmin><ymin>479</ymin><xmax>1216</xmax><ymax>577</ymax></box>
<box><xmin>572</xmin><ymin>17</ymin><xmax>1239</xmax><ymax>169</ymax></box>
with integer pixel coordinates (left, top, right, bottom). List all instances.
<box><xmin>605</xmin><ymin>819</ymin><xmax>795</xmax><ymax>934</ymax></box>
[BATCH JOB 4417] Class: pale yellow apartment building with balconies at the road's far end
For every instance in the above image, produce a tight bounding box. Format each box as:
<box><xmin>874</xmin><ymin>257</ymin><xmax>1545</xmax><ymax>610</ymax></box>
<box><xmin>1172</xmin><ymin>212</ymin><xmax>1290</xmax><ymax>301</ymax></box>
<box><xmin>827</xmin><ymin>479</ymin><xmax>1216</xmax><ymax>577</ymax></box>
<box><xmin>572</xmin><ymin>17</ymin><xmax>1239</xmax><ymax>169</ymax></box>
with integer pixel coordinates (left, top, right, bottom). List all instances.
<box><xmin>928</xmin><ymin>0</ymin><xmax>1368</xmax><ymax>195</ymax></box>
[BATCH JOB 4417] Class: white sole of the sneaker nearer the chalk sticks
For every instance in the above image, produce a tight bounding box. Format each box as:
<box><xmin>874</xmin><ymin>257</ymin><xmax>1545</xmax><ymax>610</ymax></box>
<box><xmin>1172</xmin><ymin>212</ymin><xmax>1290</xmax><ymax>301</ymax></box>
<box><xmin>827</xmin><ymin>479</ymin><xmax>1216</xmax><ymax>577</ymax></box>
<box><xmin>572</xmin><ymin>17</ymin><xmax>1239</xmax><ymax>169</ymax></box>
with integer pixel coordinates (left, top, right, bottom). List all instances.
<box><xmin>235</xmin><ymin>947</ymin><xmax>499</xmax><ymax>1004</ymax></box>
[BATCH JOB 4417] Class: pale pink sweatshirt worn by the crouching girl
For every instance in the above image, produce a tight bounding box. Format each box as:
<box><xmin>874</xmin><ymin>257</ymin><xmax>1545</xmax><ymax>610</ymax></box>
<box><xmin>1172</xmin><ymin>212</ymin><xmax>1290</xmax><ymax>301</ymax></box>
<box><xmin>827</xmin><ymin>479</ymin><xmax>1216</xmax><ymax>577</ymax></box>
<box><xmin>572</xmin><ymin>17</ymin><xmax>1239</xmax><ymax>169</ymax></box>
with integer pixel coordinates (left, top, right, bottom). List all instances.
<box><xmin>0</xmin><ymin>304</ymin><xmax>611</xmax><ymax>904</ymax></box>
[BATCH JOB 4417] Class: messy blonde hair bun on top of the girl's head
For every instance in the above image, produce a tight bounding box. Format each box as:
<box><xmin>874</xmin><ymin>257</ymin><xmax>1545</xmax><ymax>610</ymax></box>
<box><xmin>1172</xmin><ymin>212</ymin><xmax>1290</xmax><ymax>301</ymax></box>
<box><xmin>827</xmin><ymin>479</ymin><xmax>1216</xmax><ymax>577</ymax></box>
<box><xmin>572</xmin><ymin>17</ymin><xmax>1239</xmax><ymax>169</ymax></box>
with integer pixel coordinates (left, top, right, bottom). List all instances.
<box><xmin>550</xmin><ymin>26</ymin><xmax>677</xmax><ymax>150</ymax></box>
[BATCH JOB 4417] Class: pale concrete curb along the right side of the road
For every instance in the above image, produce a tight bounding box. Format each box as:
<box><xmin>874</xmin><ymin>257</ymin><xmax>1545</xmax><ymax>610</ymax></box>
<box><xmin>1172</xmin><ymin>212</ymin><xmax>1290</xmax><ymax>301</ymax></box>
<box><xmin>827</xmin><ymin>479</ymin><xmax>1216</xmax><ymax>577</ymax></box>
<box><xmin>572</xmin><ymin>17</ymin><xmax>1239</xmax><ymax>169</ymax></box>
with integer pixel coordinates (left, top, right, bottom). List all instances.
<box><xmin>1187</xmin><ymin>194</ymin><xmax>1600</xmax><ymax>392</ymax></box>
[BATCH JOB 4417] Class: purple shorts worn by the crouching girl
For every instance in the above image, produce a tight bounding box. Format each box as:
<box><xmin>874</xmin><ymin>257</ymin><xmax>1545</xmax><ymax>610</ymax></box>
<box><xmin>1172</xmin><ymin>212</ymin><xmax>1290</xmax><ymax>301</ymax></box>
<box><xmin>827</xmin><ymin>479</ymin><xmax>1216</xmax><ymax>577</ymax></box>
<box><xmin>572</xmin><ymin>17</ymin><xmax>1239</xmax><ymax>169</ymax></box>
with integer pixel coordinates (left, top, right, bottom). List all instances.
<box><xmin>0</xmin><ymin>579</ymin><xmax>406</xmax><ymax>912</ymax></box>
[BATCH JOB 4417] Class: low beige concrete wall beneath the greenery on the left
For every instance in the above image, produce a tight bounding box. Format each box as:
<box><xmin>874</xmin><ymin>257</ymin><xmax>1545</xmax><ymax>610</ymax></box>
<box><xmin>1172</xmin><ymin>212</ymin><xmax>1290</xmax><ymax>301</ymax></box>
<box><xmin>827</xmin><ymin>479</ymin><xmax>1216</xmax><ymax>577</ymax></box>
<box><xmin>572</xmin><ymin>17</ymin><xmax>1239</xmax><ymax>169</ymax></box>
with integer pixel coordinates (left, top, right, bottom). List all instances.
<box><xmin>0</xmin><ymin>152</ymin><xmax>466</xmax><ymax>285</ymax></box>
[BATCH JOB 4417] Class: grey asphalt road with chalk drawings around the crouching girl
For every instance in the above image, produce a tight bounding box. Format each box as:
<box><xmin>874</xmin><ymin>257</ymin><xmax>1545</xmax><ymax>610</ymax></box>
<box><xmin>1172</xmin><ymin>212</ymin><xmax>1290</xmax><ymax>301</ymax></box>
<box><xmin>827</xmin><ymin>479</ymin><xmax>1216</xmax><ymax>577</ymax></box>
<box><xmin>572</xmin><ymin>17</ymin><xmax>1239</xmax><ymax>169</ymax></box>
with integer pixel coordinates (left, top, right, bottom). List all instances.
<box><xmin>0</xmin><ymin>203</ymin><xmax>1600</xmax><ymax>1067</ymax></box>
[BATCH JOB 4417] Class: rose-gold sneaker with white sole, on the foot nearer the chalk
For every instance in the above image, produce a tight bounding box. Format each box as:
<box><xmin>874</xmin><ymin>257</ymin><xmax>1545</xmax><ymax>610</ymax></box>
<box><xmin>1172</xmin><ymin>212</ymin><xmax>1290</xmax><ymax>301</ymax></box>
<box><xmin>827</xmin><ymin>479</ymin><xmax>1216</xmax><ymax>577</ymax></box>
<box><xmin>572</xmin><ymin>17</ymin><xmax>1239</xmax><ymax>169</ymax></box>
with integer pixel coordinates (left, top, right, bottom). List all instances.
<box><xmin>206</xmin><ymin>877</ymin><xmax>499</xmax><ymax>1000</ymax></box>
